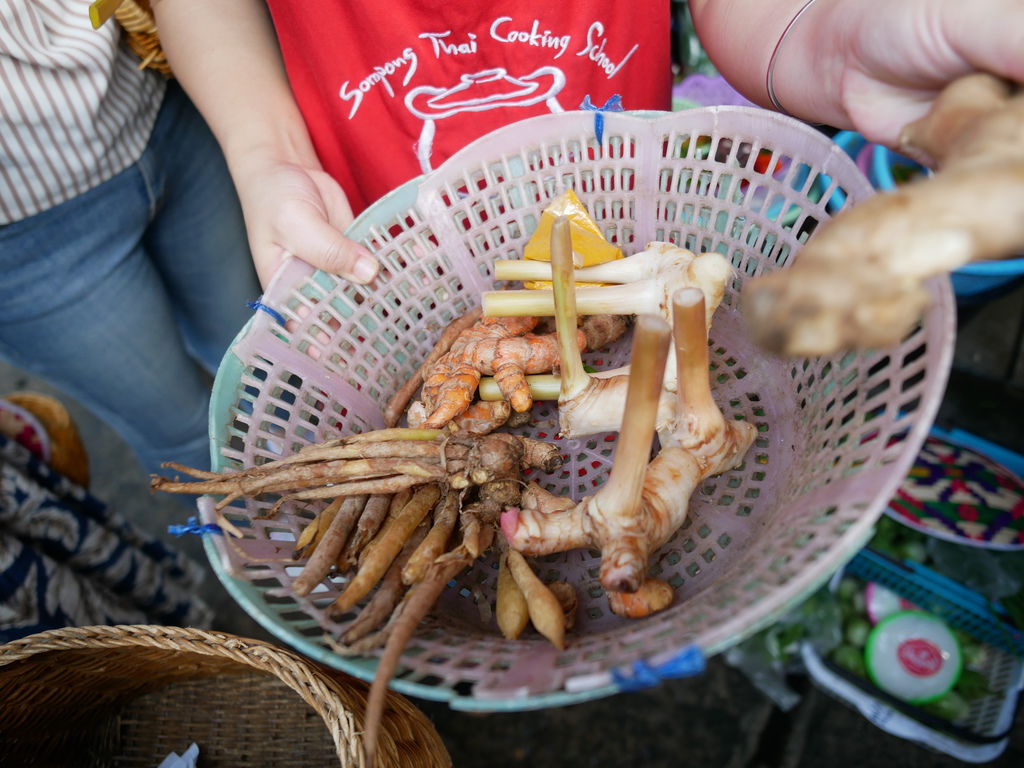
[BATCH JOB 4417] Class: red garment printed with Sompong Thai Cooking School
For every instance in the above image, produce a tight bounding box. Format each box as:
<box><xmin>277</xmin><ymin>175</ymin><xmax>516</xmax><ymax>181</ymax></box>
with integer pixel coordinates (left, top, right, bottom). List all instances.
<box><xmin>268</xmin><ymin>0</ymin><xmax>671</xmax><ymax>213</ymax></box>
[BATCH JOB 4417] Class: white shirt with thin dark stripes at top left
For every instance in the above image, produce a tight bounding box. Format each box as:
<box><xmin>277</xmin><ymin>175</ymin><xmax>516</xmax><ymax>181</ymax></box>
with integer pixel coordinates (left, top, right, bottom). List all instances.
<box><xmin>0</xmin><ymin>0</ymin><xmax>166</xmax><ymax>224</ymax></box>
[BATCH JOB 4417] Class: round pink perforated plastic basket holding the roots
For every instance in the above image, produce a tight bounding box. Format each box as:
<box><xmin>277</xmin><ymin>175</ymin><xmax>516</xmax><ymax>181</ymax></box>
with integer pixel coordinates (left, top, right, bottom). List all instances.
<box><xmin>200</xmin><ymin>108</ymin><xmax>953</xmax><ymax>710</ymax></box>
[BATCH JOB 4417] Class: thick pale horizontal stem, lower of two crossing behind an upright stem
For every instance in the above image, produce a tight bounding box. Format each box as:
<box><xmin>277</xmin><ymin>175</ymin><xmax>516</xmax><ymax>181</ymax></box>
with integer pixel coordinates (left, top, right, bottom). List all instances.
<box><xmin>482</xmin><ymin>280</ymin><xmax>664</xmax><ymax>317</ymax></box>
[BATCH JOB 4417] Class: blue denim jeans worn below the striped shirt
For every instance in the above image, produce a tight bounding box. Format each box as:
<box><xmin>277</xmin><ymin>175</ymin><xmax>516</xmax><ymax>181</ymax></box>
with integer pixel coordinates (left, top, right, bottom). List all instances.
<box><xmin>0</xmin><ymin>82</ymin><xmax>259</xmax><ymax>481</ymax></box>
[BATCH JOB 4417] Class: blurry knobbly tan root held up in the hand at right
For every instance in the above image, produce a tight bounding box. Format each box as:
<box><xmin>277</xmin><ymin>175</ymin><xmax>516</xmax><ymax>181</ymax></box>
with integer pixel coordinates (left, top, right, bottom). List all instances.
<box><xmin>741</xmin><ymin>74</ymin><xmax>1024</xmax><ymax>356</ymax></box>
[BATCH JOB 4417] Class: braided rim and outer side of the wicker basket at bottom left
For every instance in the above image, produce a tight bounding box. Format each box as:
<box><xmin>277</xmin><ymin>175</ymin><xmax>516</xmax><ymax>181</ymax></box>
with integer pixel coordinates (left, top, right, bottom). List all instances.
<box><xmin>0</xmin><ymin>625</ymin><xmax>452</xmax><ymax>766</ymax></box>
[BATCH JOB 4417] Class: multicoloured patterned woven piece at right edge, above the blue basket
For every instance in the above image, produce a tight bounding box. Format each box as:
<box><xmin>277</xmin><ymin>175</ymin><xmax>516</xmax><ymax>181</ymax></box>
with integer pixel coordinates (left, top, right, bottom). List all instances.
<box><xmin>889</xmin><ymin>437</ymin><xmax>1024</xmax><ymax>549</ymax></box>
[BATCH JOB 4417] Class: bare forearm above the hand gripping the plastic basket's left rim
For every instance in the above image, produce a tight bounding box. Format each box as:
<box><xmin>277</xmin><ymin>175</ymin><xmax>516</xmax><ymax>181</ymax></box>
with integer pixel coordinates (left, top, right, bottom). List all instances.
<box><xmin>153</xmin><ymin>0</ymin><xmax>319</xmax><ymax>181</ymax></box>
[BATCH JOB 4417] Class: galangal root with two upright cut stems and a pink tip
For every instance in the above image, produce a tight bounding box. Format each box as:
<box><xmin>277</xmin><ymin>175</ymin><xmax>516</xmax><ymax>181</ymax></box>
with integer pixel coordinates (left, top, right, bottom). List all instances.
<box><xmin>501</xmin><ymin>289</ymin><xmax>757</xmax><ymax>593</ymax></box>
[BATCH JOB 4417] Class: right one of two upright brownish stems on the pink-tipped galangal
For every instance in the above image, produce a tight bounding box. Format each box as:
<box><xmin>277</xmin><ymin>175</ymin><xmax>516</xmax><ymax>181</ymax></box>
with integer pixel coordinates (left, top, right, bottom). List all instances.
<box><xmin>672</xmin><ymin>288</ymin><xmax>725</xmax><ymax>444</ymax></box>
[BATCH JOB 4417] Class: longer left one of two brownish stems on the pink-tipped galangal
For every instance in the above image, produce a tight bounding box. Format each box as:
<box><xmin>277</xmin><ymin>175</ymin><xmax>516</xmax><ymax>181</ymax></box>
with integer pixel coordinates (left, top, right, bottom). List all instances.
<box><xmin>598</xmin><ymin>314</ymin><xmax>672</xmax><ymax>516</ymax></box>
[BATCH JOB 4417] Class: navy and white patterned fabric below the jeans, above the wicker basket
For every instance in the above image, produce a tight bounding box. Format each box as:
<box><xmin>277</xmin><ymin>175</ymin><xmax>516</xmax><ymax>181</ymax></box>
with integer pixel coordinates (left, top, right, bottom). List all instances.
<box><xmin>0</xmin><ymin>436</ymin><xmax>212</xmax><ymax>642</ymax></box>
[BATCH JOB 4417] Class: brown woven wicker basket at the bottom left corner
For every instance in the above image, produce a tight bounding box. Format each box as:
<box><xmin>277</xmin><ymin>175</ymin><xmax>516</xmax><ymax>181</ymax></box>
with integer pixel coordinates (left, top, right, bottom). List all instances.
<box><xmin>0</xmin><ymin>626</ymin><xmax>452</xmax><ymax>768</ymax></box>
